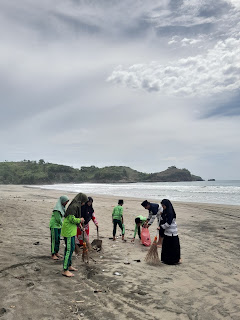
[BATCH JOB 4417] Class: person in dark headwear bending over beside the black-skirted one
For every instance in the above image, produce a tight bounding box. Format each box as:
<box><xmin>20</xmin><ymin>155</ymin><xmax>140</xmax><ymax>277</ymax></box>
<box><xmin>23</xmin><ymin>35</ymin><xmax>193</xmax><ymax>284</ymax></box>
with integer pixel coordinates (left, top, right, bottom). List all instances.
<box><xmin>141</xmin><ymin>200</ymin><xmax>164</xmax><ymax>247</ymax></box>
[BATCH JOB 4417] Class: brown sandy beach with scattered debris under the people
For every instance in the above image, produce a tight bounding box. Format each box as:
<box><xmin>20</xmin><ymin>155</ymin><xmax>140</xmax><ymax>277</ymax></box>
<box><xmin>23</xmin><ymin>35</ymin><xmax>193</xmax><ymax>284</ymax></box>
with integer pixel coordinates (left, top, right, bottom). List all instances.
<box><xmin>0</xmin><ymin>185</ymin><xmax>240</xmax><ymax>320</ymax></box>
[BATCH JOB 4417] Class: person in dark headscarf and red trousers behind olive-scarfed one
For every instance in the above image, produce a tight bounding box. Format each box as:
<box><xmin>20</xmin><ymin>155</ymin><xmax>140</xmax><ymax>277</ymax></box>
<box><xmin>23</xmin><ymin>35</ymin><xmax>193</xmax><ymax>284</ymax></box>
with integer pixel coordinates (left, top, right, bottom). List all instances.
<box><xmin>75</xmin><ymin>197</ymin><xmax>98</xmax><ymax>246</ymax></box>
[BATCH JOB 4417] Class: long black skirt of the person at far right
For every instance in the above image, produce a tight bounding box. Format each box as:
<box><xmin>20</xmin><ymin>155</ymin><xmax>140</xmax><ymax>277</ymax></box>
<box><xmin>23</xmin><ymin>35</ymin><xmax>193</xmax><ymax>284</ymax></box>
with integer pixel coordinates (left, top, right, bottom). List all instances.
<box><xmin>161</xmin><ymin>235</ymin><xmax>181</xmax><ymax>264</ymax></box>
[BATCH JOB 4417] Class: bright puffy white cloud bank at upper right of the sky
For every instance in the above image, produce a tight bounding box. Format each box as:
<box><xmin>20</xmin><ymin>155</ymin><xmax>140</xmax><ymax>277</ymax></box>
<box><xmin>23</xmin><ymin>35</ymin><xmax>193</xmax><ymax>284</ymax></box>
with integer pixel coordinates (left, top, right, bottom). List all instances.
<box><xmin>107</xmin><ymin>38</ymin><xmax>240</xmax><ymax>95</ymax></box>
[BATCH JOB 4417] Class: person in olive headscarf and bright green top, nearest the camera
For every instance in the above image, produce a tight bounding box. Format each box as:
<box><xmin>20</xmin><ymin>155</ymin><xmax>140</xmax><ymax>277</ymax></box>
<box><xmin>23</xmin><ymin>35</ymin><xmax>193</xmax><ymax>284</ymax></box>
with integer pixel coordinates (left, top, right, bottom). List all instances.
<box><xmin>62</xmin><ymin>193</ymin><xmax>88</xmax><ymax>277</ymax></box>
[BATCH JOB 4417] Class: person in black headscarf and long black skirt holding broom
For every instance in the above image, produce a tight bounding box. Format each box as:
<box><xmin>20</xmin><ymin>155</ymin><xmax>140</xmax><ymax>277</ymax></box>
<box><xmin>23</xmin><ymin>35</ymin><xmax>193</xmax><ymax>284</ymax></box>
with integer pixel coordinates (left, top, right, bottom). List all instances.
<box><xmin>159</xmin><ymin>199</ymin><xmax>181</xmax><ymax>264</ymax></box>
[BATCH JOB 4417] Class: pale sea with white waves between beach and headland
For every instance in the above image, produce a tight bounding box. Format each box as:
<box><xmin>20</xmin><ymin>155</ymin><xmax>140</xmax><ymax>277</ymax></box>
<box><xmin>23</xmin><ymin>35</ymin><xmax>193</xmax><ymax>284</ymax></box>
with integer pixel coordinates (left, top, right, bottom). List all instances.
<box><xmin>31</xmin><ymin>180</ymin><xmax>240</xmax><ymax>205</ymax></box>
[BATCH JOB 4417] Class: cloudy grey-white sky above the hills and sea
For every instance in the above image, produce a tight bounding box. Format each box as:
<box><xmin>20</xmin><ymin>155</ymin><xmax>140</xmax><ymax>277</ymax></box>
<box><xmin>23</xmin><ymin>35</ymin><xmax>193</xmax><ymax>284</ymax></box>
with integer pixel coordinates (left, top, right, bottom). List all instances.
<box><xmin>0</xmin><ymin>0</ymin><xmax>240</xmax><ymax>180</ymax></box>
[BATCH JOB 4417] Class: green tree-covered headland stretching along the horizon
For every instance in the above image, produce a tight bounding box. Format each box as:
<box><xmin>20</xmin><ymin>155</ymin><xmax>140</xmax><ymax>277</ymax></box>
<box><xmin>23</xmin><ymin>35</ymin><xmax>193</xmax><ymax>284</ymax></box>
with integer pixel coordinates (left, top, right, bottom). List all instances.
<box><xmin>0</xmin><ymin>159</ymin><xmax>204</xmax><ymax>185</ymax></box>
